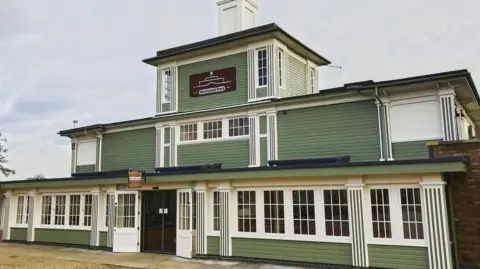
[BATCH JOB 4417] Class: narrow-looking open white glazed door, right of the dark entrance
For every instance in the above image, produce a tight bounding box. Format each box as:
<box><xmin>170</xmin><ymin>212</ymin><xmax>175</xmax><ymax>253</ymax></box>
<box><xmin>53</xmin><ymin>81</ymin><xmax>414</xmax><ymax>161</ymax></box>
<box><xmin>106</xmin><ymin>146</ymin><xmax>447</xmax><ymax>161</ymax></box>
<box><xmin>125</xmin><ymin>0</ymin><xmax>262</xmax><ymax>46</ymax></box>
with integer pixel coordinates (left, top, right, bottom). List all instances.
<box><xmin>177</xmin><ymin>190</ymin><xmax>193</xmax><ymax>259</ymax></box>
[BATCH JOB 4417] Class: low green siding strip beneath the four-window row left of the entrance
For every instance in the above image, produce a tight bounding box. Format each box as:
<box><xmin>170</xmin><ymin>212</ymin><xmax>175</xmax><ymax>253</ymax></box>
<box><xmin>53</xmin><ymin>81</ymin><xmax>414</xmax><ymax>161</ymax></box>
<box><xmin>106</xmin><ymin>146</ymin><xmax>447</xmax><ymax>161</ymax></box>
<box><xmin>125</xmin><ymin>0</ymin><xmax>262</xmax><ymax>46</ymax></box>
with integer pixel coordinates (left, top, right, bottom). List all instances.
<box><xmin>35</xmin><ymin>228</ymin><xmax>90</xmax><ymax>246</ymax></box>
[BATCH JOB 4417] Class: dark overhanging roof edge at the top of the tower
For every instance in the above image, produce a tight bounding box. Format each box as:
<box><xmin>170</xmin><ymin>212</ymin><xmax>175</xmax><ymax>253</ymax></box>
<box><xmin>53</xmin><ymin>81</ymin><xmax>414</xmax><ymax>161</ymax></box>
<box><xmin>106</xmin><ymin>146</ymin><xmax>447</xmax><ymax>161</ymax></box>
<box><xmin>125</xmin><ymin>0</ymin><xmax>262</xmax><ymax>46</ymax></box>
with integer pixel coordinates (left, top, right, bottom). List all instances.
<box><xmin>143</xmin><ymin>23</ymin><xmax>330</xmax><ymax>64</ymax></box>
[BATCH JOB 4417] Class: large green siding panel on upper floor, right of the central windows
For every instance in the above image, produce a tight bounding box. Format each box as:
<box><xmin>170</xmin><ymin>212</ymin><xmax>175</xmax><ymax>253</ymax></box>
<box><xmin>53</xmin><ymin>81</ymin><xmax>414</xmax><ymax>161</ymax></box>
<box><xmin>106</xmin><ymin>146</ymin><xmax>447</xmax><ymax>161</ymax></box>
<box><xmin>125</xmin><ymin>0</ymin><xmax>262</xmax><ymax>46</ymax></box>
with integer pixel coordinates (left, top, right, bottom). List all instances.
<box><xmin>277</xmin><ymin>100</ymin><xmax>380</xmax><ymax>161</ymax></box>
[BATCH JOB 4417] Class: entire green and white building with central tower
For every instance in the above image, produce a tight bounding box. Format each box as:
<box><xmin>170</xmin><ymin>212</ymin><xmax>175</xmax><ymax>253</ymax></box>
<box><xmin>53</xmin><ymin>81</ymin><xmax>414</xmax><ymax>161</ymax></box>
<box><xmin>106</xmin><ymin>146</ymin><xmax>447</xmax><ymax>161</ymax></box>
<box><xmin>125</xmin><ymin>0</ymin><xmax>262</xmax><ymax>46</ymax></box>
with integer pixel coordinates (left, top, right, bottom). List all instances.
<box><xmin>0</xmin><ymin>0</ymin><xmax>480</xmax><ymax>269</ymax></box>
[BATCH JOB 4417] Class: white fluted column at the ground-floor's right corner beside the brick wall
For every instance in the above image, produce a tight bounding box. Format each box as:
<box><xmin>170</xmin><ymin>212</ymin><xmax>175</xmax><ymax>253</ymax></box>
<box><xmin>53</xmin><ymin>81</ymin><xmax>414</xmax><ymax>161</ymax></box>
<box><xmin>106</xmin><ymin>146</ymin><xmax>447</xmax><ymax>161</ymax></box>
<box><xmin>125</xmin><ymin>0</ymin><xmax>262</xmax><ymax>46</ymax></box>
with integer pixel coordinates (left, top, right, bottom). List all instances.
<box><xmin>421</xmin><ymin>175</ymin><xmax>453</xmax><ymax>269</ymax></box>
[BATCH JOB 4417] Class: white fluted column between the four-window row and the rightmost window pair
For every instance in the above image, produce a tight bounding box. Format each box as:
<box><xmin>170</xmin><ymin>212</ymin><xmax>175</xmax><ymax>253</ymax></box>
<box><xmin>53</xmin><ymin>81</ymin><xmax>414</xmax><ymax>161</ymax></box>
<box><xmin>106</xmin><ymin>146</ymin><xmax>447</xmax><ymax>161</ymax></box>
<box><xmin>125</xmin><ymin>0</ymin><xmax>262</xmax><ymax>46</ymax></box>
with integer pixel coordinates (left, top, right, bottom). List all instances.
<box><xmin>346</xmin><ymin>176</ymin><xmax>369</xmax><ymax>267</ymax></box>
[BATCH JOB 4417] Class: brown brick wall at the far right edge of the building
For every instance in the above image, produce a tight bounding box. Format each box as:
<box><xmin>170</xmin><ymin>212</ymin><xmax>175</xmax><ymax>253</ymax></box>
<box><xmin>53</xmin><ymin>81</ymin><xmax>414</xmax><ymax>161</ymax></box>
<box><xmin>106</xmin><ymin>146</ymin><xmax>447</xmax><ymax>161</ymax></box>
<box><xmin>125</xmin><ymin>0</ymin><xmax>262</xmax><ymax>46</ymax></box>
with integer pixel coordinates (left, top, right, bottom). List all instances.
<box><xmin>433</xmin><ymin>140</ymin><xmax>480</xmax><ymax>268</ymax></box>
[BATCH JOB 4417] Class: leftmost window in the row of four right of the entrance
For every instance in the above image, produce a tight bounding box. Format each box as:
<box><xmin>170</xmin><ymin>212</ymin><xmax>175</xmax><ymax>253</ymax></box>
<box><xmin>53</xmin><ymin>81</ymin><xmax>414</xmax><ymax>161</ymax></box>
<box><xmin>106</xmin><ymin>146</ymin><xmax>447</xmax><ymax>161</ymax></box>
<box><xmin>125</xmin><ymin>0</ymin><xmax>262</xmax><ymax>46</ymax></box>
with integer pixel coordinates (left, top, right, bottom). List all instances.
<box><xmin>237</xmin><ymin>188</ymin><xmax>257</xmax><ymax>233</ymax></box>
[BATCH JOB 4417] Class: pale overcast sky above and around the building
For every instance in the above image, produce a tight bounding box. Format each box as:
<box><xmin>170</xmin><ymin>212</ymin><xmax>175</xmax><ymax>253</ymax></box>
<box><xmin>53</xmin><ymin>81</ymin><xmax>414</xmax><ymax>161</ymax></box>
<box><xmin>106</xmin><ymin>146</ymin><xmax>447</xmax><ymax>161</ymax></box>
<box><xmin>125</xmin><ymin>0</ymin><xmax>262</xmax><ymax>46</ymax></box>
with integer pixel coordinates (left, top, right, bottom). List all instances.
<box><xmin>0</xmin><ymin>0</ymin><xmax>480</xmax><ymax>180</ymax></box>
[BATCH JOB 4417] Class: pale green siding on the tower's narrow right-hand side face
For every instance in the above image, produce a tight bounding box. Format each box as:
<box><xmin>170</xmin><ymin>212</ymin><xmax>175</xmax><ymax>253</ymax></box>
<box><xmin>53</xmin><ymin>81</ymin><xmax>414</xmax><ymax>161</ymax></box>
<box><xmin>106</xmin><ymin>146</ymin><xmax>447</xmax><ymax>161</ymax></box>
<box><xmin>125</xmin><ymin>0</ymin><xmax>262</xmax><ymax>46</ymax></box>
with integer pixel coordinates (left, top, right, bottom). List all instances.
<box><xmin>288</xmin><ymin>56</ymin><xmax>307</xmax><ymax>96</ymax></box>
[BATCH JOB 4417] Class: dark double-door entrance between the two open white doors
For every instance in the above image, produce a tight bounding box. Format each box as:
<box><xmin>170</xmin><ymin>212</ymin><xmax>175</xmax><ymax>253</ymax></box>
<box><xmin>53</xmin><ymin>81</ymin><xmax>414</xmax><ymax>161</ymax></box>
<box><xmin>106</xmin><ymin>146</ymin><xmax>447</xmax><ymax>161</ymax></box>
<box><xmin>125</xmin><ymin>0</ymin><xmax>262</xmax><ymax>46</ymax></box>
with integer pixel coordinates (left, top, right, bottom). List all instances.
<box><xmin>141</xmin><ymin>190</ymin><xmax>177</xmax><ymax>251</ymax></box>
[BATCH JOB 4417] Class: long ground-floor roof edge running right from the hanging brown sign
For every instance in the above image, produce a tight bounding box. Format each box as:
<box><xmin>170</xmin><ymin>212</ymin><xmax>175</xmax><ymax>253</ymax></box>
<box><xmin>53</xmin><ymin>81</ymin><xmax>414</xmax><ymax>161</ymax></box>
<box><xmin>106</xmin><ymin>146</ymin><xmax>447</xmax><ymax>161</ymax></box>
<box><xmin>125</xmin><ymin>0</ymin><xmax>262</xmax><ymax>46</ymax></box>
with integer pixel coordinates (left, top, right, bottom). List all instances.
<box><xmin>145</xmin><ymin>156</ymin><xmax>470</xmax><ymax>177</ymax></box>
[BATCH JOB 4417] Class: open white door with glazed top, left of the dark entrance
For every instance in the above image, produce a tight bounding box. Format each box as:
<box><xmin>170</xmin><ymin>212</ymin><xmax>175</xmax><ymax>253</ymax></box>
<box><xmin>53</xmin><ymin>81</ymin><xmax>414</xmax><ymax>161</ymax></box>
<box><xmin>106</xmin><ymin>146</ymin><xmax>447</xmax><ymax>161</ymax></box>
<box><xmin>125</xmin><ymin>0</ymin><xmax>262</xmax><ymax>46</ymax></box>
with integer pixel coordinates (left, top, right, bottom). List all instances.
<box><xmin>113</xmin><ymin>191</ymin><xmax>140</xmax><ymax>252</ymax></box>
